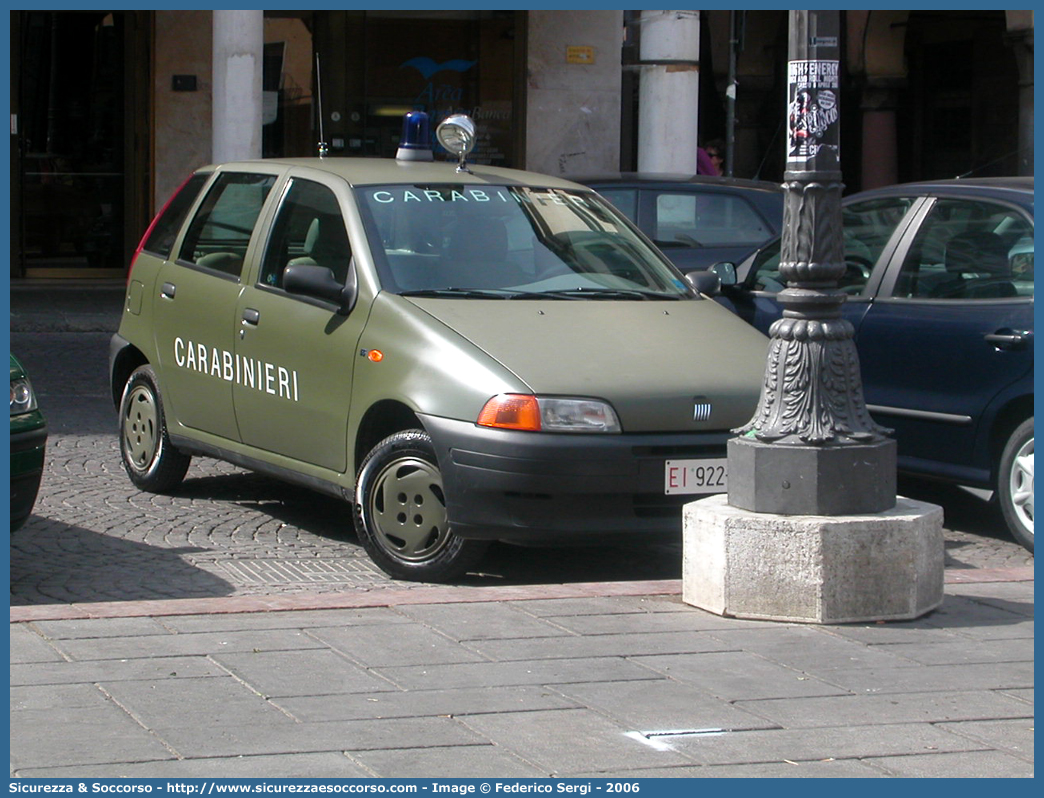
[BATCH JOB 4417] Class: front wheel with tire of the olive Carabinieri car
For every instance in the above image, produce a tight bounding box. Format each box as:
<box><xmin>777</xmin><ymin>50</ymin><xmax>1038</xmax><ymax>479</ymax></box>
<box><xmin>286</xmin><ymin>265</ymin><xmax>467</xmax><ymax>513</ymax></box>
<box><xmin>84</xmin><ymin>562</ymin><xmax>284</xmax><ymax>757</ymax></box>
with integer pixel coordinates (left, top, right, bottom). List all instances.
<box><xmin>355</xmin><ymin>429</ymin><xmax>489</xmax><ymax>582</ymax></box>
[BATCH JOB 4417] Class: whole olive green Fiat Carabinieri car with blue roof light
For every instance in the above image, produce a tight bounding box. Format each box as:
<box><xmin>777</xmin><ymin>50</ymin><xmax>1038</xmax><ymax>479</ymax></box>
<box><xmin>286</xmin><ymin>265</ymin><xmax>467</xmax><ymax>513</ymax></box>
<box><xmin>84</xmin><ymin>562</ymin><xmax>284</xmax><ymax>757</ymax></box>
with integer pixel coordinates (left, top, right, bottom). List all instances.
<box><xmin>110</xmin><ymin>114</ymin><xmax>767</xmax><ymax>582</ymax></box>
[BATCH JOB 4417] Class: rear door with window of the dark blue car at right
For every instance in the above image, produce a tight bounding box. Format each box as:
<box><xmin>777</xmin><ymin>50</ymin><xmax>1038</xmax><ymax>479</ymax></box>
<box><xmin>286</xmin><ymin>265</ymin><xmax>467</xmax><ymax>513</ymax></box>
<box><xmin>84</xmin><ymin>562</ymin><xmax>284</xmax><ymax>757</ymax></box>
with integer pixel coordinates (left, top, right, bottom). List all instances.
<box><xmin>857</xmin><ymin>197</ymin><xmax>1034</xmax><ymax>478</ymax></box>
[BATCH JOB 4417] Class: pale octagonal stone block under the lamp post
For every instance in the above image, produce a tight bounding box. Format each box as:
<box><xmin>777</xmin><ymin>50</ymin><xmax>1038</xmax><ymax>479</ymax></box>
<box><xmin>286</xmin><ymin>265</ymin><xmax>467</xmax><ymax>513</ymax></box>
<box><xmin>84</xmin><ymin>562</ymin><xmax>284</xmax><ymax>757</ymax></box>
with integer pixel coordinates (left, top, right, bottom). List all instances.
<box><xmin>682</xmin><ymin>495</ymin><xmax>944</xmax><ymax>624</ymax></box>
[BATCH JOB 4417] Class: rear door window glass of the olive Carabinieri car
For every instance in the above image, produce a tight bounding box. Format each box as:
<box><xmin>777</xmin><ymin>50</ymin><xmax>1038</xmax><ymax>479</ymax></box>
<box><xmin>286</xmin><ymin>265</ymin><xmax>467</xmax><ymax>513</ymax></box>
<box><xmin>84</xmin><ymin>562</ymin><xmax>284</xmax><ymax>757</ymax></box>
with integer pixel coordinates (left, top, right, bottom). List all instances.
<box><xmin>179</xmin><ymin>172</ymin><xmax>276</xmax><ymax>277</ymax></box>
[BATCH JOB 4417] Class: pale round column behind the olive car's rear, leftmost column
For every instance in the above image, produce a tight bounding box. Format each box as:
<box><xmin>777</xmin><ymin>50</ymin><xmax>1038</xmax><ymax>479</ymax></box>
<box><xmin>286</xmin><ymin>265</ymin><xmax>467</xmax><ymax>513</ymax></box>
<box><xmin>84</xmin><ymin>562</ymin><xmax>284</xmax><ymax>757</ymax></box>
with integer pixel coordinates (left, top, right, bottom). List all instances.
<box><xmin>212</xmin><ymin>10</ymin><xmax>264</xmax><ymax>163</ymax></box>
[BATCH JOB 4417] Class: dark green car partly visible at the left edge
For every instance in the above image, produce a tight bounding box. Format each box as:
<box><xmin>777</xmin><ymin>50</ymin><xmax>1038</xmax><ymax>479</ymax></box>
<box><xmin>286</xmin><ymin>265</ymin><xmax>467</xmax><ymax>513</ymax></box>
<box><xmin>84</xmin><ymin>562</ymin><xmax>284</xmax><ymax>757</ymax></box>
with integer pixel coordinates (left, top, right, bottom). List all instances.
<box><xmin>10</xmin><ymin>355</ymin><xmax>47</xmax><ymax>532</ymax></box>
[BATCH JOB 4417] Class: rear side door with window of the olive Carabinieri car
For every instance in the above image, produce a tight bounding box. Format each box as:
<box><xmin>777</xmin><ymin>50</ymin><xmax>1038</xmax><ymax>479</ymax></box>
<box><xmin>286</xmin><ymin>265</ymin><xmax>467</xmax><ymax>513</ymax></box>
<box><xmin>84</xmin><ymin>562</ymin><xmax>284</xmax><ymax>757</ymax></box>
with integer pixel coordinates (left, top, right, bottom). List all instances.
<box><xmin>153</xmin><ymin>171</ymin><xmax>276</xmax><ymax>441</ymax></box>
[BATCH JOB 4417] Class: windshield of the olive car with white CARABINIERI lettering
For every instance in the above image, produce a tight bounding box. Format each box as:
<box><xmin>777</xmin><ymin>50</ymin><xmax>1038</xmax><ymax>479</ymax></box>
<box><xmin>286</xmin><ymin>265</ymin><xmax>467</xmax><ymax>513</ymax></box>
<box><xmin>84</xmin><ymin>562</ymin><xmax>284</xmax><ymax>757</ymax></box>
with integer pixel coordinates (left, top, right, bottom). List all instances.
<box><xmin>357</xmin><ymin>185</ymin><xmax>692</xmax><ymax>300</ymax></box>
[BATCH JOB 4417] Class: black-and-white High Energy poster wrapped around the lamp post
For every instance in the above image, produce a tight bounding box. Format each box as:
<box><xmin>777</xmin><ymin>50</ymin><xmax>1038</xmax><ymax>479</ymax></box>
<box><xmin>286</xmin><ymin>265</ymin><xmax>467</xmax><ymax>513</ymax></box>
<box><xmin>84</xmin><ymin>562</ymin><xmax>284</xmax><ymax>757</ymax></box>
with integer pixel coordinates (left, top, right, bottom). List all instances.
<box><xmin>787</xmin><ymin>61</ymin><xmax>840</xmax><ymax>169</ymax></box>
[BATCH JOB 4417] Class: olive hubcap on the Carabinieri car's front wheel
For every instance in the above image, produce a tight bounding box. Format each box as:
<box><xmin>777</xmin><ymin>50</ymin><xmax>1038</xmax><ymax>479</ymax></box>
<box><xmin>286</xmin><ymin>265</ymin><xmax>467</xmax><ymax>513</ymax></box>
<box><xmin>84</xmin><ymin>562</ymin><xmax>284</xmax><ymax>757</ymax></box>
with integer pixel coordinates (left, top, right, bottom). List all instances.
<box><xmin>370</xmin><ymin>456</ymin><xmax>449</xmax><ymax>562</ymax></box>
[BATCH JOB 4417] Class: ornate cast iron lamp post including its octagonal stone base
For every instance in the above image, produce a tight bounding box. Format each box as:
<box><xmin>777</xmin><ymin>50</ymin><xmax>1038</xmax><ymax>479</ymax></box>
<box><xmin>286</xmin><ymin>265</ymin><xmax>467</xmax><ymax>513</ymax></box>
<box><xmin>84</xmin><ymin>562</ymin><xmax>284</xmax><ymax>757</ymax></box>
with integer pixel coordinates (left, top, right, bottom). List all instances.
<box><xmin>682</xmin><ymin>11</ymin><xmax>943</xmax><ymax>624</ymax></box>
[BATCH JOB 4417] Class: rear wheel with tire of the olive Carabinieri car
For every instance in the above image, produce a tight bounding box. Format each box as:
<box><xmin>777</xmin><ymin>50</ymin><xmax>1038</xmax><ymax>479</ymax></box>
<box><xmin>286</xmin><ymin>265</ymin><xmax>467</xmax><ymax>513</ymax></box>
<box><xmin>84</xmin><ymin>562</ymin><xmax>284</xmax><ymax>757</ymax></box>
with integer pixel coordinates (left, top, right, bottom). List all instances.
<box><xmin>120</xmin><ymin>366</ymin><xmax>192</xmax><ymax>493</ymax></box>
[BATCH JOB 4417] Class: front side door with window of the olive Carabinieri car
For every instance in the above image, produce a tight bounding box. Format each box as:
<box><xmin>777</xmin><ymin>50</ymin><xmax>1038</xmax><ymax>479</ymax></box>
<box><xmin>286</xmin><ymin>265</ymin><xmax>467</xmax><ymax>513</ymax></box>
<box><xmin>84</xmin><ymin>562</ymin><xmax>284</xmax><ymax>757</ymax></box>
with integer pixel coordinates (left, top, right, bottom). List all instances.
<box><xmin>232</xmin><ymin>175</ymin><xmax>365</xmax><ymax>473</ymax></box>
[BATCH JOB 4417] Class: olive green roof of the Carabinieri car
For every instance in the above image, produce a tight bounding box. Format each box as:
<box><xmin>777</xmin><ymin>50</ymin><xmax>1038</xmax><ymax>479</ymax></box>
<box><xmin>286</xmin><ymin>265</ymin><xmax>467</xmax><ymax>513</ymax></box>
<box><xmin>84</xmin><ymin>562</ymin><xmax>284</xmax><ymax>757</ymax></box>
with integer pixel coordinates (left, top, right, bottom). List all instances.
<box><xmin>198</xmin><ymin>158</ymin><xmax>588</xmax><ymax>190</ymax></box>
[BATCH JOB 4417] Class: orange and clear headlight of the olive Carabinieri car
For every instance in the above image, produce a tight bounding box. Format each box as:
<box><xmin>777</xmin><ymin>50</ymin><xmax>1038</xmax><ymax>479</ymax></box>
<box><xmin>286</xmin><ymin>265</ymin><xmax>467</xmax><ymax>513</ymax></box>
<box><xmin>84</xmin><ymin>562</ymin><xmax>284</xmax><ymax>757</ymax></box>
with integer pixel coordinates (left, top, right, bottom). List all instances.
<box><xmin>477</xmin><ymin>394</ymin><xmax>620</xmax><ymax>432</ymax></box>
